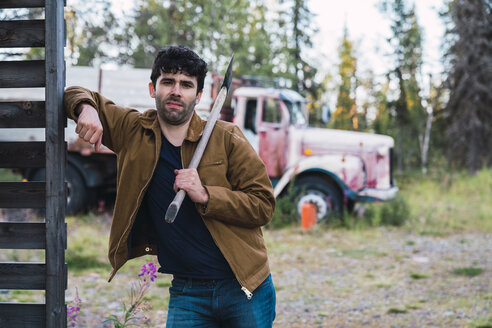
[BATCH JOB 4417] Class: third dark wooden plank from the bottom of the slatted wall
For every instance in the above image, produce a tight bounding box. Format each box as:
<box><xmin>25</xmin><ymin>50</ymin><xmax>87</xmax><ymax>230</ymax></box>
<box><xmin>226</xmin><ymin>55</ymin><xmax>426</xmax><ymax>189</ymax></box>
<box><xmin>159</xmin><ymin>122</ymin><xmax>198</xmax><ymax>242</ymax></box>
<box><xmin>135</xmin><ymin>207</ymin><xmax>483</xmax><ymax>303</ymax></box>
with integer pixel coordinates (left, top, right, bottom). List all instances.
<box><xmin>0</xmin><ymin>222</ymin><xmax>46</xmax><ymax>249</ymax></box>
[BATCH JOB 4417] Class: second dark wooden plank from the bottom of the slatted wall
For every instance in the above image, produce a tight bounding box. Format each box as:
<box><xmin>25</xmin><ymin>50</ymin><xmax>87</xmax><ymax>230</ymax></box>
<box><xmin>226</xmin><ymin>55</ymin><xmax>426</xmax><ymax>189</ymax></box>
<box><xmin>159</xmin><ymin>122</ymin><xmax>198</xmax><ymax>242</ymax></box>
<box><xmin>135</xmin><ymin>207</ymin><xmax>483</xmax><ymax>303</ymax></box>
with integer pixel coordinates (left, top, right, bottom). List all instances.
<box><xmin>0</xmin><ymin>262</ymin><xmax>46</xmax><ymax>290</ymax></box>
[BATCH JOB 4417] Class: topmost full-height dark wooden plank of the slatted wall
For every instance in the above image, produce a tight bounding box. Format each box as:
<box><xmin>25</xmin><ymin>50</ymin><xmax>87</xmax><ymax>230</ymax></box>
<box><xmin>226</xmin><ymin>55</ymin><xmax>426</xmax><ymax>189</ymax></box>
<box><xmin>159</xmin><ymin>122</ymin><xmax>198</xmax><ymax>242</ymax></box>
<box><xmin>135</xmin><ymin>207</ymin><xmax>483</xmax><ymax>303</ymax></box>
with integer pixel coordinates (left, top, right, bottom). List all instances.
<box><xmin>0</xmin><ymin>20</ymin><xmax>44</xmax><ymax>48</ymax></box>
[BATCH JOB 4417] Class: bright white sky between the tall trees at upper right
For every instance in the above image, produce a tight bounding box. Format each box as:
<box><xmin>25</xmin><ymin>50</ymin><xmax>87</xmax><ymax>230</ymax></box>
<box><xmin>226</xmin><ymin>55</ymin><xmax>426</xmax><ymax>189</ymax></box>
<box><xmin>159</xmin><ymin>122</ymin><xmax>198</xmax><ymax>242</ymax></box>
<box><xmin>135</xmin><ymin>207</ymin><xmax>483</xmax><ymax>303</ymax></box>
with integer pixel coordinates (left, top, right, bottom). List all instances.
<box><xmin>308</xmin><ymin>0</ymin><xmax>444</xmax><ymax>79</ymax></box>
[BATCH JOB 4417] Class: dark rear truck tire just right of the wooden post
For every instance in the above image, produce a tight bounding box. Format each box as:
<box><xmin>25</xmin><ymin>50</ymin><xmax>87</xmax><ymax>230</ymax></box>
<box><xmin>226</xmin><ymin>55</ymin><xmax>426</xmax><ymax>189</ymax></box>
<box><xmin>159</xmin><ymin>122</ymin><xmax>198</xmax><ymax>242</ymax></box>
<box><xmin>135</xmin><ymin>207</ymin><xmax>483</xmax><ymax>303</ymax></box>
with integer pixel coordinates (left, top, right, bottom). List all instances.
<box><xmin>31</xmin><ymin>165</ymin><xmax>88</xmax><ymax>215</ymax></box>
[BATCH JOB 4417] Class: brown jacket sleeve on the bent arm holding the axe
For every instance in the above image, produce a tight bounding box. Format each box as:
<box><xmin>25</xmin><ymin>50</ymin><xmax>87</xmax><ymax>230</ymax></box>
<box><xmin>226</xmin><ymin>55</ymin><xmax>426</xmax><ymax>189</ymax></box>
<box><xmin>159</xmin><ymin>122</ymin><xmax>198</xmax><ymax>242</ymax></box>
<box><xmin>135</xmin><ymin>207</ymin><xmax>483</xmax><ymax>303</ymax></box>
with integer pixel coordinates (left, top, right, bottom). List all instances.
<box><xmin>197</xmin><ymin>126</ymin><xmax>275</xmax><ymax>228</ymax></box>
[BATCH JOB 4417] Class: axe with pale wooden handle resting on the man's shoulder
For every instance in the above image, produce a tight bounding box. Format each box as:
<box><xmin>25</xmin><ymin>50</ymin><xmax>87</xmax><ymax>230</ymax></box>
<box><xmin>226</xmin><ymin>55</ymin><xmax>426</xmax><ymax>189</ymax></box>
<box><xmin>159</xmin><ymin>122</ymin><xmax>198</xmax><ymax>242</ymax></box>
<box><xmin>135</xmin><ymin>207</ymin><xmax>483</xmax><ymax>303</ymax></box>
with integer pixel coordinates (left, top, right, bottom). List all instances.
<box><xmin>164</xmin><ymin>55</ymin><xmax>234</xmax><ymax>223</ymax></box>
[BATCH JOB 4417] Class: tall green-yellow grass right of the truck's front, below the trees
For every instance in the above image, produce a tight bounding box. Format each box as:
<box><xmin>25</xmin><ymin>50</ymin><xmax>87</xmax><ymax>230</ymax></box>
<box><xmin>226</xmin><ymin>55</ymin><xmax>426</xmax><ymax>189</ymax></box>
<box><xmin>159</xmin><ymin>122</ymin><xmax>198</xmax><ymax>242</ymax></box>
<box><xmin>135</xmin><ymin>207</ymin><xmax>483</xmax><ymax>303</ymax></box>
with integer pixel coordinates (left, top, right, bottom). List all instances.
<box><xmin>342</xmin><ymin>169</ymin><xmax>492</xmax><ymax>234</ymax></box>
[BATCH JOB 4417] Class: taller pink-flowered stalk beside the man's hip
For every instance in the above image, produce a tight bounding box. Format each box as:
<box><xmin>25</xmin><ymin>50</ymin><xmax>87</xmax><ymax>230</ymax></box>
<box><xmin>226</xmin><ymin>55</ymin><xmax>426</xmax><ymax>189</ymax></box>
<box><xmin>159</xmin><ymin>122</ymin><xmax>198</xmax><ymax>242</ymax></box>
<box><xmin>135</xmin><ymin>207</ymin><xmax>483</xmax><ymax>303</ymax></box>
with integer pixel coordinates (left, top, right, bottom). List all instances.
<box><xmin>104</xmin><ymin>262</ymin><xmax>157</xmax><ymax>328</ymax></box>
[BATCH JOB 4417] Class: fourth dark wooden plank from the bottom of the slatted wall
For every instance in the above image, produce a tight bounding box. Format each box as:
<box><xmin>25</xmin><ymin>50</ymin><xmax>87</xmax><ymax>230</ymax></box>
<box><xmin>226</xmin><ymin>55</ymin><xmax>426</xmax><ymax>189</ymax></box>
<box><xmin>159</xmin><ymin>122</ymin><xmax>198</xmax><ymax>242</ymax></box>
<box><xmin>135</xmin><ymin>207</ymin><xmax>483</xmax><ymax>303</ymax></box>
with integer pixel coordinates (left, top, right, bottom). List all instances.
<box><xmin>0</xmin><ymin>182</ymin><xmax>44</xmax><ymax>209</ymax></box>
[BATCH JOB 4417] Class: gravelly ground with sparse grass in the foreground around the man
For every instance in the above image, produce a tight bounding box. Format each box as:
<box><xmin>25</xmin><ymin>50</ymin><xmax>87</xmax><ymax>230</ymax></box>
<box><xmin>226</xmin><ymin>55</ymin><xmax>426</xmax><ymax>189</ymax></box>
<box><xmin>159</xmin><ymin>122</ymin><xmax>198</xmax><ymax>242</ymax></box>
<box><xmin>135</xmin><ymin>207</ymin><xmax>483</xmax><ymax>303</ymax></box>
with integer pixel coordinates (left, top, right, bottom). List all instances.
<box><xmin>62</xmin><ymin>228</ymin><xmax>492</xmax><ymax>328</ymax></box>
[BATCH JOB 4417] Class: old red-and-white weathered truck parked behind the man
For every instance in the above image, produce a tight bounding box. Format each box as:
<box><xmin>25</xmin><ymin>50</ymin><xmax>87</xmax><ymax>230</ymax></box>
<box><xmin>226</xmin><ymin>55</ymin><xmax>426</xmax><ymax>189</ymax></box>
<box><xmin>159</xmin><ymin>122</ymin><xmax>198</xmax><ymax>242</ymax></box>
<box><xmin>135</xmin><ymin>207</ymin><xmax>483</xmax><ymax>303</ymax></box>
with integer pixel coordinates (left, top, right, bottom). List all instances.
<box><xmin>0</xmin><ymin>68</ymin><xmax>398</xmax><ymax>220</ymax></box>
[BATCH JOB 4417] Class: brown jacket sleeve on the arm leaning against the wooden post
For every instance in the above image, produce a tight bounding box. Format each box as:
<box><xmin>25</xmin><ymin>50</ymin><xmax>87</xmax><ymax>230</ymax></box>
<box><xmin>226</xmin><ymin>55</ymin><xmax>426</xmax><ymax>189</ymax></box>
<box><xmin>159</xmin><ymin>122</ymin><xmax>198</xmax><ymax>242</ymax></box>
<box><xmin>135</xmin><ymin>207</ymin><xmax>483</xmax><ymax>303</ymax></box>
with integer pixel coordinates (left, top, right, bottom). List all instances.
<box><xmin>63</xmin><ymin>87</ymin><xmax>140</xmax><ymax>153</ymax></box>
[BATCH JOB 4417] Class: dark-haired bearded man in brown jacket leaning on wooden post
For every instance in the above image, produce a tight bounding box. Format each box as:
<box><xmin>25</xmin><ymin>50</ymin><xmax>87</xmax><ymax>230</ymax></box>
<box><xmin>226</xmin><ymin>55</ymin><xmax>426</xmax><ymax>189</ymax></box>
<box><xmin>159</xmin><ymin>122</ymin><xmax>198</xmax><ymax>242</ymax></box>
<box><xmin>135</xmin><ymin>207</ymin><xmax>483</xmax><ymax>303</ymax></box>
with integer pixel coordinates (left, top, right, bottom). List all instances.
<box><xmin>64</xmin><ymin>46</ymin><xmax>275</xmax><ymax>328</ymax></box>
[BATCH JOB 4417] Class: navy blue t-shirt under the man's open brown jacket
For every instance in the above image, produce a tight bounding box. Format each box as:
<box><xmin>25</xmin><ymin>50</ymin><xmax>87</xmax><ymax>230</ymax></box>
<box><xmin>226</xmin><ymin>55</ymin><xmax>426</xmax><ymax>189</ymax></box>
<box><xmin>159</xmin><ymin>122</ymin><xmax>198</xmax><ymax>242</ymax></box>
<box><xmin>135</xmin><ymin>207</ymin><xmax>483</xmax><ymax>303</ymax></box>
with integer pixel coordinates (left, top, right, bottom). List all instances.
<box><xmin>142</xmin><ymin>135</ymin><xmax>234</xmax><ymax>279</ymax></box>
